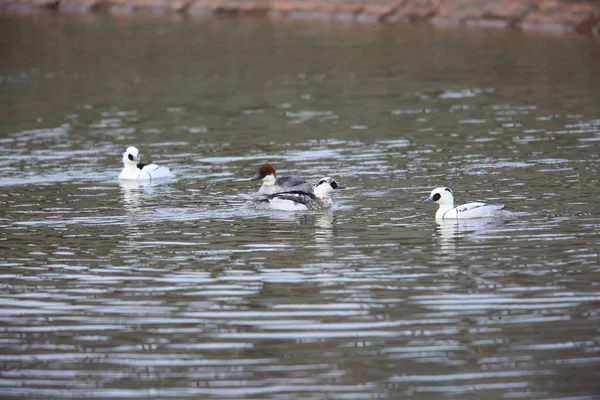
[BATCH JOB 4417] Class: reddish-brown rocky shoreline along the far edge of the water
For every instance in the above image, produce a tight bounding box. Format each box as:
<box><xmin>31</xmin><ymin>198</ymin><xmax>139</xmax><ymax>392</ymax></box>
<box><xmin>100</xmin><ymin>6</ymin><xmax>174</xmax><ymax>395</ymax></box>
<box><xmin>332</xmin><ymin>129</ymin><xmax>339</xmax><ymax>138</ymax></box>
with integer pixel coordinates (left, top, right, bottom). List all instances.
<box><xmin>0</xmin><ymin>0</ymin><xmax>600</xmax><ymax>36</ymax></box>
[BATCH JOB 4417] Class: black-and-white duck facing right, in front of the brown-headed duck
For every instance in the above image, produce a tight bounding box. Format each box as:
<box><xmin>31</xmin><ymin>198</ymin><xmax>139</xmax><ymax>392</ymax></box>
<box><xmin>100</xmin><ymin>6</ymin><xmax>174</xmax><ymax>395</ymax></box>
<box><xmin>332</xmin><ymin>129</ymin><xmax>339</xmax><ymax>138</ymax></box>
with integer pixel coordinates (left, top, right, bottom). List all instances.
<box><xmin>259</xmin><ymin>177</ymin><xmax>343</xmax><ymax>211</ymax></box>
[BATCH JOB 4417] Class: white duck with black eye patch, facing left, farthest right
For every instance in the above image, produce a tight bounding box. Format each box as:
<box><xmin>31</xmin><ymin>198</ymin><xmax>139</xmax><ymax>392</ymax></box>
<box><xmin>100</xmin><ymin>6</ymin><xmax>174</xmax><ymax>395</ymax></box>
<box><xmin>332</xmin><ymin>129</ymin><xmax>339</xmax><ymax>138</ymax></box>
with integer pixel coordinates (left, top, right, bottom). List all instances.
<box><xmin>423</xmin><ymin>187</ymin><xmax>508</xmax><ymax>220</ymax></box>
